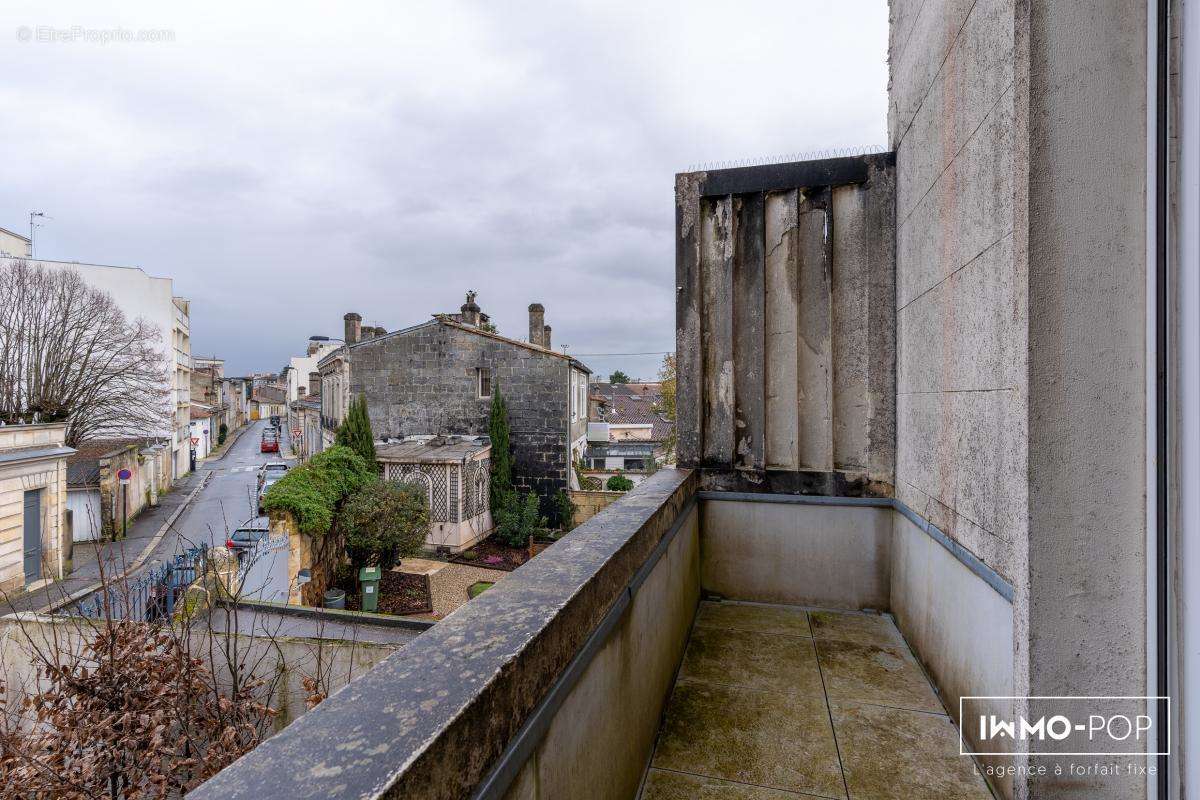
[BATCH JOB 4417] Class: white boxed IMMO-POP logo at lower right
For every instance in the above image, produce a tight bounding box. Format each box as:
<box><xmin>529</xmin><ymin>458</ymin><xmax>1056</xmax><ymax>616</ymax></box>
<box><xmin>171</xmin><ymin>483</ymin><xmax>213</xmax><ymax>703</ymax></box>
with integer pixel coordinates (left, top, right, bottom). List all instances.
<box><xmin>959</xmin><ymin>696</ymin><xmax>1171</xmax><ymax>756</ymax></box>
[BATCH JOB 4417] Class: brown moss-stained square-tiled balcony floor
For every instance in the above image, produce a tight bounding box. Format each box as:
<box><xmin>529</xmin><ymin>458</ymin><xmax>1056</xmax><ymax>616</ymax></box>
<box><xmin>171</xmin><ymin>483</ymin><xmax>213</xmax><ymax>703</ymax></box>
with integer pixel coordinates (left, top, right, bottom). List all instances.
<box><xmin>641</xmin><ymin>602</ymin><xmax>991</xmax><ymax>800</ymax></box>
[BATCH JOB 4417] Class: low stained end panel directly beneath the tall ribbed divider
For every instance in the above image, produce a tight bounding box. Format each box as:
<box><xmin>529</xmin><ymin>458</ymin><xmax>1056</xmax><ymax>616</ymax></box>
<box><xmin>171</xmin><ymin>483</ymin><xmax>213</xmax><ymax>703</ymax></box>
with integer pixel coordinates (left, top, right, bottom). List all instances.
<box><xmin>701</xmin><ymin>500</ymin><xmax>893</xmax><ymax>609</ymax></box>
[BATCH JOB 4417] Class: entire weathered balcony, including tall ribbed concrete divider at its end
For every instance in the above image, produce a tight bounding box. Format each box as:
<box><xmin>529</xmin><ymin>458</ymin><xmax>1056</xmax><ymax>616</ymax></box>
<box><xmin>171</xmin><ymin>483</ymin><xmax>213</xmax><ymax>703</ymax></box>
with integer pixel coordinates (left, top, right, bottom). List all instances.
<box><xmin>190</xmin><ymin>154</ymin><xmax>1014</xmax><ymax>800</ymax></box>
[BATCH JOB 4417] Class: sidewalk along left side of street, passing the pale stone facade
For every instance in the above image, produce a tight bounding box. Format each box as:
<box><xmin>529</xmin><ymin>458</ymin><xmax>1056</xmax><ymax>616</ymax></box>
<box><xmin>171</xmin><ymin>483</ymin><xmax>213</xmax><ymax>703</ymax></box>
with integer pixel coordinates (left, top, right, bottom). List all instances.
<box><xmin>0</xmin><ymin>471</ymin><xmax>211</xmax><ymax>614</ymax></box>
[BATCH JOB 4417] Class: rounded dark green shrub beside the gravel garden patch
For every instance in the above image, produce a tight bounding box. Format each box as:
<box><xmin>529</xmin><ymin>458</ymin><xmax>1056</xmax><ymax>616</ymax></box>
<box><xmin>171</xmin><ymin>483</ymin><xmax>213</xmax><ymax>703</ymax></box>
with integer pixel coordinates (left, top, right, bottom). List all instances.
<box><xmin>337</xmin><ymin>481</ymin><xmax>430</xmax><ymax>570</ymax></box>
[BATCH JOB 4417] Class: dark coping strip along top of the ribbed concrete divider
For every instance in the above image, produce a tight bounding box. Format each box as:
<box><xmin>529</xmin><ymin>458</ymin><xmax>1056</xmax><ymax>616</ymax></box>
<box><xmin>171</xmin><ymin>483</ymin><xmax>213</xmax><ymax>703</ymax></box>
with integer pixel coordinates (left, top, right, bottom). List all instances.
<box><xmin>692</xmin><ymin>151</ymin><xmax>896</xmax><ymax>197</ymax></box>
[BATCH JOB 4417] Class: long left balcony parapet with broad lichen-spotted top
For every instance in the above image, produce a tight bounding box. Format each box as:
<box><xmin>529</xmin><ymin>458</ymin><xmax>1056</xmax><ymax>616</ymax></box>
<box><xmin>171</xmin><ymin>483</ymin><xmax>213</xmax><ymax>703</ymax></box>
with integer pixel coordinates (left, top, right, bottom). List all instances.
<box><xmin>188</xmin><ymin>469</ymin><xmax>698</xmax><ymax>800</ymax></box>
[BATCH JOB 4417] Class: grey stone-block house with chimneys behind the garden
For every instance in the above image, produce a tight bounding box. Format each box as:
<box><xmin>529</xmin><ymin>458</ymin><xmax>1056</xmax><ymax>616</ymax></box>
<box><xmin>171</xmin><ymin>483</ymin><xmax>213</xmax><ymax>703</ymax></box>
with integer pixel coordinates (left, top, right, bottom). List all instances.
<box><xmin>318</xmin><ymin>293</ymin><xmax>592</xmax><ymax>511</ymax></box>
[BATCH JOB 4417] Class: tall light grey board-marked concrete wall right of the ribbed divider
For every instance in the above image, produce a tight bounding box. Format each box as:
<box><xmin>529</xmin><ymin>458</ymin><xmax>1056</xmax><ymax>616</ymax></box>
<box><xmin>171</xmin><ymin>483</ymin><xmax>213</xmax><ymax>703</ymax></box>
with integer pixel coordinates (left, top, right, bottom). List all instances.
<box><xmin>888</xmin><ymin>0</ymin><xmax>1027</xmax><ymax>587</ymax></box>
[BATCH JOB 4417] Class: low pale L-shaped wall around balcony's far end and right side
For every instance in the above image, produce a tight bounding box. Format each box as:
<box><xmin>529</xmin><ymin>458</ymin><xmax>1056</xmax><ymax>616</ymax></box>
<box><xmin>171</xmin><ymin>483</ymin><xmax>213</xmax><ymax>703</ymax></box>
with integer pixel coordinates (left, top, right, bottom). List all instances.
<box><xmin>700</xmin><ymin>493</ymin><xmax>1015</xmax><ymax>798</ymax></box>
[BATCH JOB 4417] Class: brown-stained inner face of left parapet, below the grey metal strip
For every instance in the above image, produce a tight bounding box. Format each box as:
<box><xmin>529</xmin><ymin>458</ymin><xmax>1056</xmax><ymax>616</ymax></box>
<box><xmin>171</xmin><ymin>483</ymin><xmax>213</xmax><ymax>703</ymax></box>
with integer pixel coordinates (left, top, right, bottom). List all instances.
<box><xmin>505</xmin><ymin>506</ymin><xmax>700</xmax><ymax>800</ymax></box>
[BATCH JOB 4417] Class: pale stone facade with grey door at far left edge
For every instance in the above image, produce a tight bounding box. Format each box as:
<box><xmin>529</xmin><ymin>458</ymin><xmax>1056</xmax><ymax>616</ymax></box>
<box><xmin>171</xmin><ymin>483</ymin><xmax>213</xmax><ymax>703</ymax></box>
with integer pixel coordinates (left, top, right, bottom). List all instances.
<box><xmin>0</xmin><ymin>423</ymin><xmax>74</xmax><ymax>591</ymax></box>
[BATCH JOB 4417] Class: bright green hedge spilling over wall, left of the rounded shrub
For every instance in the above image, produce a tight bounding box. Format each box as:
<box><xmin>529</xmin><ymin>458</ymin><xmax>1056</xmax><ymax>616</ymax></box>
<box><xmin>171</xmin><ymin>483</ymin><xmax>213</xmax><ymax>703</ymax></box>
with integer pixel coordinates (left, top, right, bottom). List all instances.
<box><xmin>263</xmin><ymin>446</ymin><xmax>379</xmax><ymax>536</ymax></box>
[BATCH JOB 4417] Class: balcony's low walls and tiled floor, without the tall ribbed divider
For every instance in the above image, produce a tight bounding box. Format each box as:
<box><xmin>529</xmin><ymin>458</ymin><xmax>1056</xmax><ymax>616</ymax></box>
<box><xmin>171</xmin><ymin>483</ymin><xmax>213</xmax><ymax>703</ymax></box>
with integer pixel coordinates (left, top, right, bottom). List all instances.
<box><xmin>190</xmin><ymin>470</ymin><xmax>1012</xmax><ymax>800</ymax></box>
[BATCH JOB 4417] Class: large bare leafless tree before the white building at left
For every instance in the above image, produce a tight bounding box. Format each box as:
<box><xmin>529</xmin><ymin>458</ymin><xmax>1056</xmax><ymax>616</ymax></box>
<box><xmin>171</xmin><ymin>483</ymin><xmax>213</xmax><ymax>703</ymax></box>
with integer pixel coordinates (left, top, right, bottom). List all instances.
<box><xmin>0</xmin><ymin>260</ymin><xmax>170</xmax><ymax>445</ymax></box>
